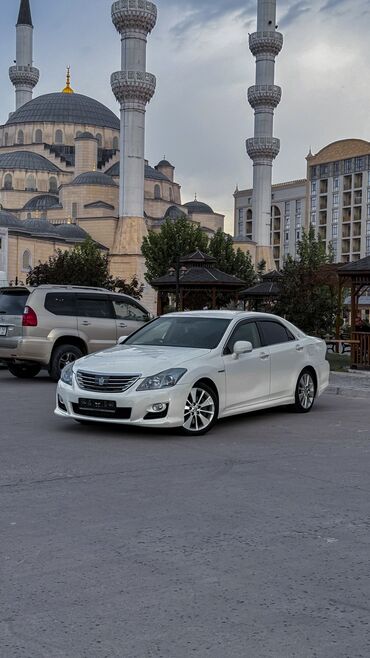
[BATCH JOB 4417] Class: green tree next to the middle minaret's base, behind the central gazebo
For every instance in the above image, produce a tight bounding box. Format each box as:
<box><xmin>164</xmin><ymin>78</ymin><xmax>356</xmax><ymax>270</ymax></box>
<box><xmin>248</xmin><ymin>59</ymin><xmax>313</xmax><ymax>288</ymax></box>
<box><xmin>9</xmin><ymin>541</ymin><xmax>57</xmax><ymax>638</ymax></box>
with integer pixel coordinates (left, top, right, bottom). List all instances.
<box><xmin>141</xmin><ymin>215</ymin><xmax>208</xmax><ymax>283</ymax></box>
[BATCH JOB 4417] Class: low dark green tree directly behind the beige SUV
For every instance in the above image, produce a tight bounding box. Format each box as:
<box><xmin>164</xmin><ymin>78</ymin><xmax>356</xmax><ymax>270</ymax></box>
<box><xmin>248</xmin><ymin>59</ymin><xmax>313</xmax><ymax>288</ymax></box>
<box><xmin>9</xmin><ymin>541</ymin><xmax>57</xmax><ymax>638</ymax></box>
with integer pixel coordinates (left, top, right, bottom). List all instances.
<box><xmin>27</xmin><ymin>238</ymin><xmax>144</xmax><ymax>299</ymax></box>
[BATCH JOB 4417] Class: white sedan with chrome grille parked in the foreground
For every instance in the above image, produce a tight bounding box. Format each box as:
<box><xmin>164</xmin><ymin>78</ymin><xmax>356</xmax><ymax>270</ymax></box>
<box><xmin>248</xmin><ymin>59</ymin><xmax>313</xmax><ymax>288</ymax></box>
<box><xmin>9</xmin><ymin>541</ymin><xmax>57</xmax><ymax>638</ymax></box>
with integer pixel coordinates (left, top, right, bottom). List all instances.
<box><xmin>55</xmin><ymin>311</ymin><xmax>329</xmax><ymax>435</ymax></box>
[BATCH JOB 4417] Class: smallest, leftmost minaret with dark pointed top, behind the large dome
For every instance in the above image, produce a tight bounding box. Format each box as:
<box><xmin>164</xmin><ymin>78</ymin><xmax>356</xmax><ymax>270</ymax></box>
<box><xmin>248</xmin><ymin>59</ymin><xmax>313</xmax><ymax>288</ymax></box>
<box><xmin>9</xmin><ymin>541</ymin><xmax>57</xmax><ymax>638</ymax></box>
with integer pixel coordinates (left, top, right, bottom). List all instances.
<box><xmin>9</xmin><ymin>0</ymin><xmax>40</xmax><ymax>110</ymax></box>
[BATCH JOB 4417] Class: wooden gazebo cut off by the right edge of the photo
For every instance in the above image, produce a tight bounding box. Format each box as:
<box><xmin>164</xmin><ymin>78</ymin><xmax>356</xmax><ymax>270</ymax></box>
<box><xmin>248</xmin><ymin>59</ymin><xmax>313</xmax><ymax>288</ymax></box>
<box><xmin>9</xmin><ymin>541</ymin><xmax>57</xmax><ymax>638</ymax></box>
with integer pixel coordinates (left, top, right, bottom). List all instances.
<box><xmin>338</xmin><ymin>256</ymin><xmax>370</xmax><ymax>369</ymax></box>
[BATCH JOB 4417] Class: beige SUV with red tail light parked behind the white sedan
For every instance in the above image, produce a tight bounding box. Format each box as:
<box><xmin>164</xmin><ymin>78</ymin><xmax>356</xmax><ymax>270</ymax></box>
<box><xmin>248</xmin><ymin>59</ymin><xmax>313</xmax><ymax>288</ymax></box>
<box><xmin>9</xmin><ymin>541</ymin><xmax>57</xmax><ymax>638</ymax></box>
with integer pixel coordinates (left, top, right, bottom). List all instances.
<box><xmin>0</xmin><ymin>285</ymin><xmax>152</xmax><ymax>381</ymax></box>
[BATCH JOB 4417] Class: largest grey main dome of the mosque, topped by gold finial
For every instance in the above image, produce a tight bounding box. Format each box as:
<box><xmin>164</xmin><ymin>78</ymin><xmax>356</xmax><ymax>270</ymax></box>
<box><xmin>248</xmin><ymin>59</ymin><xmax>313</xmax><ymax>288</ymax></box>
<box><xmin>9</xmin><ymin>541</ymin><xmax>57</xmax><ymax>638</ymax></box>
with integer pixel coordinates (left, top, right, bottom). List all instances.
<box><xmin>6</xmin><ymin>92</ymin><xmax>120</xmax><ymax>130</ymax></box>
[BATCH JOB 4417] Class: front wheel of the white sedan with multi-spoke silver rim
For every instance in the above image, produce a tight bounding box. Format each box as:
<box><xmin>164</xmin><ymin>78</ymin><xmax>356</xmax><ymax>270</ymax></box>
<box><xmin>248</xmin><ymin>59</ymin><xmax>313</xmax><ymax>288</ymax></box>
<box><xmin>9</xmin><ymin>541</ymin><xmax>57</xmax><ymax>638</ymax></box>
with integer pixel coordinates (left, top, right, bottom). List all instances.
<box><xmin>181</xmin><ymin>382</ymin><xmax>218</xmax><ymax>436</ymax></box>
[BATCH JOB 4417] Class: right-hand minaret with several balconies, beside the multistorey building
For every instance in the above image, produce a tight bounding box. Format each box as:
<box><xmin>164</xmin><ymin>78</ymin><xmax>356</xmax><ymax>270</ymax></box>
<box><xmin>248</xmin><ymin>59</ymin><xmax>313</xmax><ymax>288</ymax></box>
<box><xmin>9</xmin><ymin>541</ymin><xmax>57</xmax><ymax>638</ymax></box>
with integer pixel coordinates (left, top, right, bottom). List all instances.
<box><xmin>246</xmin><ymin>0</ymin><xmax>283</xmax><ymax>264</ymax></box>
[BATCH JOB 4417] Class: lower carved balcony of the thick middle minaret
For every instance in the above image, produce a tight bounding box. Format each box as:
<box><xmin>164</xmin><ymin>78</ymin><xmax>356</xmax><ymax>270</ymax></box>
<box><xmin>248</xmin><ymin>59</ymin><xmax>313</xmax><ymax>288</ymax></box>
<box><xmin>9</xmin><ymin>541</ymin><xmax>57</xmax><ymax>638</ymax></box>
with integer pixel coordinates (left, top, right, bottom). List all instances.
<box><xmin>111</xmin><ymin>71</ymin><xmax>156</xmax><ymax>104</ymax></box>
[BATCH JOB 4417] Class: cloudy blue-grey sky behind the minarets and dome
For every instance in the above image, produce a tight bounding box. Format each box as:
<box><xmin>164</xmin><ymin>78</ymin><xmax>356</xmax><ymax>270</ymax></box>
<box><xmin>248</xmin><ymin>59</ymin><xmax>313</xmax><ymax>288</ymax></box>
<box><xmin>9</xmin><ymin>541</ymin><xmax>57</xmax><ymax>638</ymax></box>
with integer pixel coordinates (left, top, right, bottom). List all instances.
<box><xmin>0</xmin><ymin>0</ymin><xmax>370</xmax><ymax>231</ymax></box>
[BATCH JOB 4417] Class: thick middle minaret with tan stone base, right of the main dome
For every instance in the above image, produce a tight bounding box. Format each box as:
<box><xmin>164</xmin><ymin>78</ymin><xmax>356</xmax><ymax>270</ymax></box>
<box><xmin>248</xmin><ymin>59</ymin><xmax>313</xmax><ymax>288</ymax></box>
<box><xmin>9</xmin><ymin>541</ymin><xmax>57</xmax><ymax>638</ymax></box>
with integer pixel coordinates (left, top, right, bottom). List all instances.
<box><xmin>111</xmin><ymin>0</ymin><xmax>157</xmax><ymax>302</ymax></box>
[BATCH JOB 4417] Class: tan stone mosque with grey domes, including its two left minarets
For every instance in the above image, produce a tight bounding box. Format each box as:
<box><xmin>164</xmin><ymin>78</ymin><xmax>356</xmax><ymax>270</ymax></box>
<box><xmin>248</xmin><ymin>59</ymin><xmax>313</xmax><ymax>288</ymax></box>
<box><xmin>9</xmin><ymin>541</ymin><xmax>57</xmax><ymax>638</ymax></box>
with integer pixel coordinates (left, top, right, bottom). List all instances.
<box><xmin>0</xmin><ymin>0</ymin><xmax>224</xmax><ymax>302</ymax></box>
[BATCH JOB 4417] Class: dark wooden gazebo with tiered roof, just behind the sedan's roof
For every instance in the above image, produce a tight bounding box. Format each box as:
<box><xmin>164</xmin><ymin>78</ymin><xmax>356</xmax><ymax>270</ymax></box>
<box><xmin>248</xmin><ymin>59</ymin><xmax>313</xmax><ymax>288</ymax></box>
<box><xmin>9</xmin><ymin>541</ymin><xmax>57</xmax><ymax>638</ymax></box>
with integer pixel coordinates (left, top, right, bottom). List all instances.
<box><xmin>151</xmin><ymin>250</ymin><xmax>245</xmax><ymax>315</ymax></box>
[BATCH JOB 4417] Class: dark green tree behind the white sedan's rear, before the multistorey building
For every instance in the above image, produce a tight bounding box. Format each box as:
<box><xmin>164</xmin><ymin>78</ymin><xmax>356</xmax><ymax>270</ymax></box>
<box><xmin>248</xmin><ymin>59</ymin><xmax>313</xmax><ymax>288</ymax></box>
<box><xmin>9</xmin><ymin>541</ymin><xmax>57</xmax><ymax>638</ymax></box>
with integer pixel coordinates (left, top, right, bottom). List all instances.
<box><xmin>275</xmin><ymin>227</ymin><xmax>338</xmax><ymax>336</ymax></box>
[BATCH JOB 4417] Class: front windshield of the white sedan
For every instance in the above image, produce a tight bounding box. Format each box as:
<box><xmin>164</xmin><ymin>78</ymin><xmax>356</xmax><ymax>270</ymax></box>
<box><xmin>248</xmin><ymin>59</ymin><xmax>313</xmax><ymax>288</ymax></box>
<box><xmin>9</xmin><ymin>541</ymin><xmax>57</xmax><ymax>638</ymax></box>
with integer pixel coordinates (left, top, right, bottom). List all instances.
<box><xmin>124</xmin><ymin>316</ymin><xmax>231</xmax><ymax>350</ymax></box>
